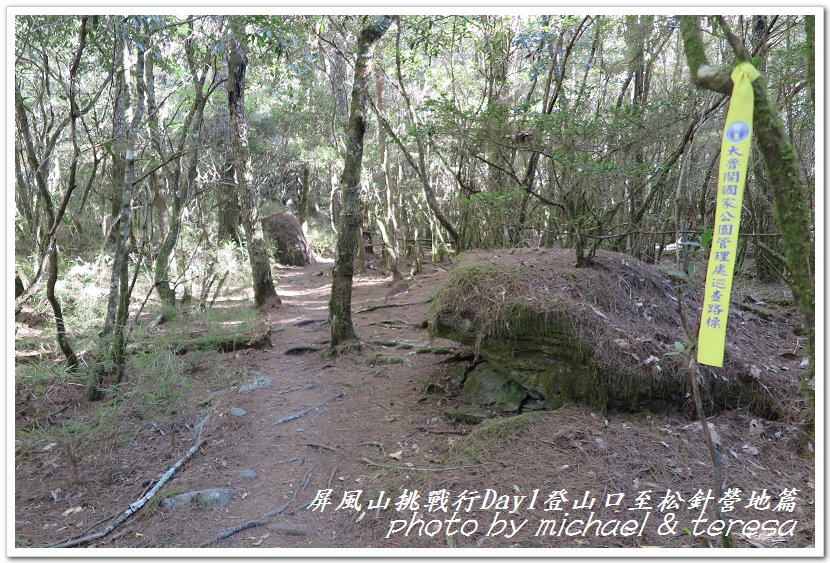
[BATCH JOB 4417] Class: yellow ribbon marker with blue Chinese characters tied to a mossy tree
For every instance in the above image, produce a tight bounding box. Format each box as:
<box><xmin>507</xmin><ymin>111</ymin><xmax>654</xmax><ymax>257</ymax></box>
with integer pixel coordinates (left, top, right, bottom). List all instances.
<box><xmin>697</xmin><ymin>62</ymin><xmax>761</xmax><ymax>367</ymax></box>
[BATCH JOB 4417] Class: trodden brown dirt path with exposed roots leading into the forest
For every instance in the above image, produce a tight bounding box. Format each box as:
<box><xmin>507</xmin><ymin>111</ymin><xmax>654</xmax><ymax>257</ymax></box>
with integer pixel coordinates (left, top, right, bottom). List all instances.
<box><xmin>109</xmin><ymin>264</ymin><xmax>468</xmax><ymax>547</ymax></box>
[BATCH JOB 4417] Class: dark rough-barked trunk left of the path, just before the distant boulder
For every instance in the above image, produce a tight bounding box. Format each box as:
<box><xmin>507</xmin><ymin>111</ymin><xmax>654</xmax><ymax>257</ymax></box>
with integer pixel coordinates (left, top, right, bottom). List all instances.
<box><xmin>228</xmin><ymin>34</ymin><xmax>280</xmax><ymax>307</ymax></box>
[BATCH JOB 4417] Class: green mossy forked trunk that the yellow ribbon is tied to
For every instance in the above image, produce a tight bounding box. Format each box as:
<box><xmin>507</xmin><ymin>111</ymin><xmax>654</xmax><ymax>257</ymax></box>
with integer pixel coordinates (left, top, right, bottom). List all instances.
<box><xmin>679</xmin><ymin>16</ymin><xmax>815</xmax><ymax>366</ymax></box>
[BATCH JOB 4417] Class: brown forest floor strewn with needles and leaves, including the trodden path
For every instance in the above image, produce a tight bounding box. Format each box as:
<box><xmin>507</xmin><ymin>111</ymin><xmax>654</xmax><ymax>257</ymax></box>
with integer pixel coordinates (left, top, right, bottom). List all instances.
<box><xmin>15</xmin><ymin>263</ymin><xmax>815</xmax><ymax>549</ymax></box>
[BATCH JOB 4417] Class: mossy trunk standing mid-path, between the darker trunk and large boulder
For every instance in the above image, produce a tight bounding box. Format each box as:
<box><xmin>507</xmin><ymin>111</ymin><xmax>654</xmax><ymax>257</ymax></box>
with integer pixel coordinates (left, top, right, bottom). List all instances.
<box><xmin>329</xmin><ymin>16</ymin><xmax>394</xmax><ymax>348</ymax></box>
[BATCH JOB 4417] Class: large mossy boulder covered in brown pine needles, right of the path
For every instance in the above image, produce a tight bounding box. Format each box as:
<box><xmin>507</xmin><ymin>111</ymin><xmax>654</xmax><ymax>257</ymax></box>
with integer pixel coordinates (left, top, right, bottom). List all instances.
<box><xmin>430</xmin><ymin>249</ymin><xmax>797</xmax><ymax>418</ymax></box>
